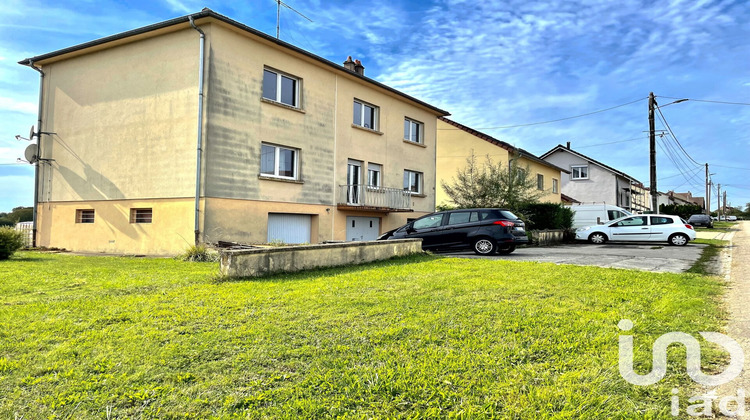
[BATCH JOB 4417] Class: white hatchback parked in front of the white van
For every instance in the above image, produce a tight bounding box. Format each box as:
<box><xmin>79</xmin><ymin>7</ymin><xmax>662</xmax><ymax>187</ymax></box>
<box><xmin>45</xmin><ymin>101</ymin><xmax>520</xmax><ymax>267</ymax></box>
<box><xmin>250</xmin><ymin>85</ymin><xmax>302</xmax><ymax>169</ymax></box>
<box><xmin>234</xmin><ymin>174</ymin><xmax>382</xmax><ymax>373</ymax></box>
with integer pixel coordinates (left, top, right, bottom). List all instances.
<box><xmin>576</xmin><ymin>214</ymin><xmax>695</xmax><ymax>245</ymax></box>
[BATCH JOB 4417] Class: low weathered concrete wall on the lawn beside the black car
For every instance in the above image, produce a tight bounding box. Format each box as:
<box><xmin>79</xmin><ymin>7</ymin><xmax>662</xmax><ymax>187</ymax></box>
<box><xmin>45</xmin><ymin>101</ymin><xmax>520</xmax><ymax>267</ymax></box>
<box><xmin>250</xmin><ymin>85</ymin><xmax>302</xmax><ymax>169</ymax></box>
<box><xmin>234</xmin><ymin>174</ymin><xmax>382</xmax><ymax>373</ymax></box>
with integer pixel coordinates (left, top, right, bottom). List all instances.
<box><xmin>221</xmin><ymin>239</ymin><xmax>422</xmax><ymax>277</ymax></box>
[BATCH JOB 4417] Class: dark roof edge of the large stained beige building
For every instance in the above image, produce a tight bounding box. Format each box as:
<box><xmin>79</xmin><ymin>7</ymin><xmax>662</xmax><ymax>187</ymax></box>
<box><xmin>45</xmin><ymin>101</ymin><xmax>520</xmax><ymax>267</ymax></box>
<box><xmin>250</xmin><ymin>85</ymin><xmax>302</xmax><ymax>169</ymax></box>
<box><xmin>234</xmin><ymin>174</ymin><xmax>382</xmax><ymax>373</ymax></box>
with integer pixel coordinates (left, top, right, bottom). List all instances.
<box><xmin>18</xmin><ymin>7</ymin><xmax>450</xmax><ymax>115</ymax></box>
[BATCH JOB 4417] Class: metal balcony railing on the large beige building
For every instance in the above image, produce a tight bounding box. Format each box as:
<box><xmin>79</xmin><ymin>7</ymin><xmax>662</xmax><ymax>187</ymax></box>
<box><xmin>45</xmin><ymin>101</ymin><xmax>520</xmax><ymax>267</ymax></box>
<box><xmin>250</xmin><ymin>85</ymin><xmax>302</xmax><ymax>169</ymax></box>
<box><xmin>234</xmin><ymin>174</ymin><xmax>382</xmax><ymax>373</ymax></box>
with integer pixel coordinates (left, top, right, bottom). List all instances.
<box><xmin>338</xmin><ymin>184</ymin><xmax>412</xmax><ymax>211</ymax></box>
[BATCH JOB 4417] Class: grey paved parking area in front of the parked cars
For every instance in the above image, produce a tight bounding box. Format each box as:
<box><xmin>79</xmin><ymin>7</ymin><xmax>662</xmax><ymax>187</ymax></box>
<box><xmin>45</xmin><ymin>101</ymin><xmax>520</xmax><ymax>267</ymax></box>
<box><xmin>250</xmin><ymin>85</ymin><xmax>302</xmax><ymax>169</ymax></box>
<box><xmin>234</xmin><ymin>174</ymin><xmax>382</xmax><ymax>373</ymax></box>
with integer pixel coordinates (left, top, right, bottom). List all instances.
<box><xmin>441</xmin><ymin>242</ymin><xmax>706</xmax><ymax>273</ymax></box>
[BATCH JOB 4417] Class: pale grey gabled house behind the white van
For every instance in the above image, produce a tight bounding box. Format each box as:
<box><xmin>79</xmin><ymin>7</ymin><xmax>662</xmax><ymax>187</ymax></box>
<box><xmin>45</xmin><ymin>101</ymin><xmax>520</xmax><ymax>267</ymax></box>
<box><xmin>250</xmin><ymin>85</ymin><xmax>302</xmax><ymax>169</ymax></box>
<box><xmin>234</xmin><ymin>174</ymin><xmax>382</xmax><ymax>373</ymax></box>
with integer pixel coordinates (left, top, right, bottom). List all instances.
<box><xmin>541</xmin><ymin>143</ymin><xmax>651</xmax><ymax>212</ymax></box>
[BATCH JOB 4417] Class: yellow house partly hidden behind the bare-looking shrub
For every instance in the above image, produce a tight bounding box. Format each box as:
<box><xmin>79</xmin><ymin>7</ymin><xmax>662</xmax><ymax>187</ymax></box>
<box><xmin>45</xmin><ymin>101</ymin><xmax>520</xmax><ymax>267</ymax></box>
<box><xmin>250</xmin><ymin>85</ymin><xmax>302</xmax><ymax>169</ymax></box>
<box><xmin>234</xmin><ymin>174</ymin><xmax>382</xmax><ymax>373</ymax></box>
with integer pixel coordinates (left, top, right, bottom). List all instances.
<box><xmin>437</xmin><ymin>117</ymin><xmax>569</xmax><ymax>205</ymax></box>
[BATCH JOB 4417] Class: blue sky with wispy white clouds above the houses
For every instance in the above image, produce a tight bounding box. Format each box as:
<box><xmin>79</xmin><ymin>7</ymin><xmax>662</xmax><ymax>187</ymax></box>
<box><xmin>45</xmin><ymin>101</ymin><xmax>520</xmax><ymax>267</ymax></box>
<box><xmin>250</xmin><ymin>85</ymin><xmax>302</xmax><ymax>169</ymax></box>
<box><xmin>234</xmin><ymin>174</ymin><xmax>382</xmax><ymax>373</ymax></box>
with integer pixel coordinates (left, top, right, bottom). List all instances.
<box><xmin>0</xmin><ymin>0</ymin><xmax>750</xmax><ymax>211</ymax></box>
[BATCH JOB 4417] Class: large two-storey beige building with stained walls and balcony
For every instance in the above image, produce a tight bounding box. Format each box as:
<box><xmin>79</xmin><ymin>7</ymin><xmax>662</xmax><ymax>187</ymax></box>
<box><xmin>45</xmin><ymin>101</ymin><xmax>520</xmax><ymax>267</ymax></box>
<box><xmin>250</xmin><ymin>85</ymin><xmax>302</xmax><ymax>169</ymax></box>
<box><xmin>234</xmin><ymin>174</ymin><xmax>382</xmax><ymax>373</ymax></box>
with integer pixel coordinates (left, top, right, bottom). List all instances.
<box><xmin>20</xmin><ymin>9</ymin><xmax>448</xmax><ymax>254</ymax></box>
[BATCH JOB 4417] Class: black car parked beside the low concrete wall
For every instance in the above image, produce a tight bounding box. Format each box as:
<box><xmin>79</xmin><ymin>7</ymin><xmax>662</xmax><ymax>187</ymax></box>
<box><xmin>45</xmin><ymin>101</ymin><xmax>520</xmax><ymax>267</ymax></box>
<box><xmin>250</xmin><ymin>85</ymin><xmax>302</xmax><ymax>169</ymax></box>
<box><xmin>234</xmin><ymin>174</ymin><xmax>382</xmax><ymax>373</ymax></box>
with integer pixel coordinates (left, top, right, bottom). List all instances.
<box><xmin>378</xmin><ymin>209</ymin><xmax>529</xmax><ymax>255</ymax></box>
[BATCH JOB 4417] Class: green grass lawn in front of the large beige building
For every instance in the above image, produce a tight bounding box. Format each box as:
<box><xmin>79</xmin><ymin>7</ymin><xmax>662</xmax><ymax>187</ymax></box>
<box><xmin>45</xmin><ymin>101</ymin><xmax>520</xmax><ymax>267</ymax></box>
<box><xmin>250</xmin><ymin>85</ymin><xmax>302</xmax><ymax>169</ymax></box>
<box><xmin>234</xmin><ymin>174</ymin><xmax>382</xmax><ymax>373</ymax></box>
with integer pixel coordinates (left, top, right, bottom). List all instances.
<box><xmin>0</xmin><ymin>252</ymin><xmax>723</xmax><ymax>419</ymax></box>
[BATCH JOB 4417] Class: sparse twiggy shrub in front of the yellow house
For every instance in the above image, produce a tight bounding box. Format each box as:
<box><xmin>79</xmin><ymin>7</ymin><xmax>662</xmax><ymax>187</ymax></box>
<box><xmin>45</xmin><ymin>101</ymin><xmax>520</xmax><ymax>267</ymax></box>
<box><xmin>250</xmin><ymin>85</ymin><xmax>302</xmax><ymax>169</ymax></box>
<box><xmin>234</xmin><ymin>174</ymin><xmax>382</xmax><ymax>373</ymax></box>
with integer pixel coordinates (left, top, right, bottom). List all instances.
<box><xmin>441</xmin><ymin>153</ymin><xmax>543</xmax><ymax>209</ymax></box>
